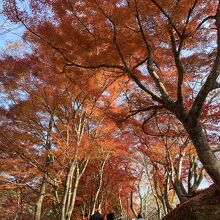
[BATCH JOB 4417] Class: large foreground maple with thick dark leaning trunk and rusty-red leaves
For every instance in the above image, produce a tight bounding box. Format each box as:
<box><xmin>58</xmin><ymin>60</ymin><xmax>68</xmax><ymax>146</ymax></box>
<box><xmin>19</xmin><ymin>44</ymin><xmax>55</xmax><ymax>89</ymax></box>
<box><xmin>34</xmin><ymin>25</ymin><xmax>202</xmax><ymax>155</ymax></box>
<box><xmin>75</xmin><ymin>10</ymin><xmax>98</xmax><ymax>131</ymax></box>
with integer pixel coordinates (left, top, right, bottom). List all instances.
<box><xmin>4</xmin><ymin>0</ymin><xmax>220</xmax><ymax>191</ymax></box>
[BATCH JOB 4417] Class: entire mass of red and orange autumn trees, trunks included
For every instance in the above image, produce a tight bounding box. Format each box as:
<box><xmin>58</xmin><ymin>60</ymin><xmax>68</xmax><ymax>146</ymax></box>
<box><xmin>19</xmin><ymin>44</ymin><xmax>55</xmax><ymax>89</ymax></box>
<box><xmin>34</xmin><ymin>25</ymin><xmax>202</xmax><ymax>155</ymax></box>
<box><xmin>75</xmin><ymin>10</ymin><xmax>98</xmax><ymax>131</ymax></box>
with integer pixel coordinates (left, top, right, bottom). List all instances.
<box><xmin>0</xmin><ymin>0</ymin><xmax>220</xmax><ymax>220</ymax></box>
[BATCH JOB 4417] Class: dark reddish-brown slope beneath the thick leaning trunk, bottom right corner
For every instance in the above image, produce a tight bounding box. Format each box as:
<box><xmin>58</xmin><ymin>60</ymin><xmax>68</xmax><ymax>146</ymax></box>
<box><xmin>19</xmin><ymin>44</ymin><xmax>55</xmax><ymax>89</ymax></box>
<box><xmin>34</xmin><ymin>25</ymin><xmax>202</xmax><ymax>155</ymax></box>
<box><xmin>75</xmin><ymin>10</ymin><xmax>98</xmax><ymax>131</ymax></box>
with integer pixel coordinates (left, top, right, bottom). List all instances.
<box><xmin>163</xmin><ymin>185</ymin><xmax>220</xmax><ymax>220</ymax></box>
